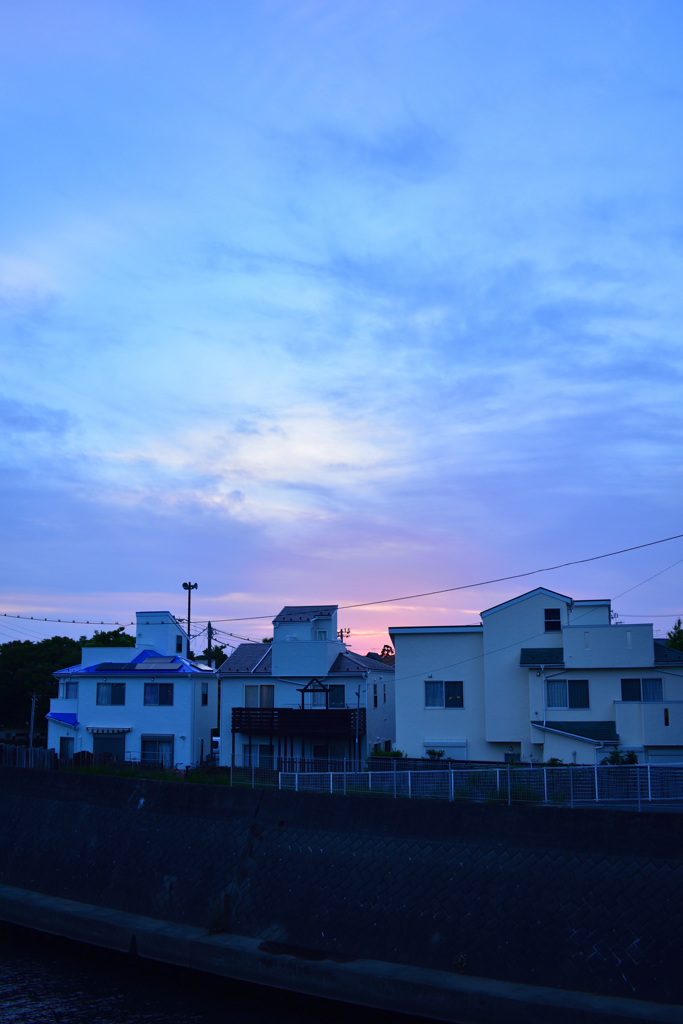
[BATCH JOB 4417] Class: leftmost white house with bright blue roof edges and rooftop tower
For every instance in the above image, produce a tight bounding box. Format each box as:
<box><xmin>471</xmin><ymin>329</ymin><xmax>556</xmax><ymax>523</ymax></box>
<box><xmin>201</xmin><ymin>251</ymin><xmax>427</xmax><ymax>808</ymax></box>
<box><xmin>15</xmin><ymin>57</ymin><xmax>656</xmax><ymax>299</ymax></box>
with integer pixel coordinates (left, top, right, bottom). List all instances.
<box><xmin>47</xmin><ymin>611</ymin><xmax>218</xmax><ymax>767</ymax></box>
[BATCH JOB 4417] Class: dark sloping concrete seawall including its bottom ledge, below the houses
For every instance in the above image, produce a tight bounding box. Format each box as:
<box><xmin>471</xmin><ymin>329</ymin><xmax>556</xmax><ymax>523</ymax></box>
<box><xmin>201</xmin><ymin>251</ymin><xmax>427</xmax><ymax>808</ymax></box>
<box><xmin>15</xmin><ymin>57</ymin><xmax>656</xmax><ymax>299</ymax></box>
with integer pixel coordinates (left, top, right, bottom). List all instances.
<box><xmin>0</xmin><ymin>769</ymin><xmax>683</xmax><ymax>1024</ymax></box>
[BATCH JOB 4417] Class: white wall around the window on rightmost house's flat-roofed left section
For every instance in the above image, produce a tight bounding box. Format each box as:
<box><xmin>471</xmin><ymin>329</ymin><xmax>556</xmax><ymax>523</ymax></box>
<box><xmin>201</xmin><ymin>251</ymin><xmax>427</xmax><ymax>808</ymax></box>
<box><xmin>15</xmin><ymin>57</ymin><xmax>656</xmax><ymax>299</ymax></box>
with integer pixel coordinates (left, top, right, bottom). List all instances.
<box><xmin>389</xmin><ymin>627</ymin><xmax>485</xmax><ymax>760</ymax></box>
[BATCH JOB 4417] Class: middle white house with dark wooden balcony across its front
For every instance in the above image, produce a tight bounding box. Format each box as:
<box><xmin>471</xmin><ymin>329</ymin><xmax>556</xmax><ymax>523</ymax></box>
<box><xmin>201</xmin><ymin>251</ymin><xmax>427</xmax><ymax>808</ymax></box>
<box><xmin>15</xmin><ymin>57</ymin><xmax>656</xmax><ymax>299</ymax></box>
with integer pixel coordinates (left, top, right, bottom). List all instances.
<box><xmin>219</xmin><ymin>605</ymin><xmax>394</xmax><ymax>767</ymax></box>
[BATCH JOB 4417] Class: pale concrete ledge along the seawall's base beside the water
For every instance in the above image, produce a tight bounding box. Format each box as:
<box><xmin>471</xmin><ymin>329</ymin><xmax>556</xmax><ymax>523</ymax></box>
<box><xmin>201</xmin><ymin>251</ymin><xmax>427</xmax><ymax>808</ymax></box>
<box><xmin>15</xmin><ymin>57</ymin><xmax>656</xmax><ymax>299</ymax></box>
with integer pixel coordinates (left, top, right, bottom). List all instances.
<box><xmin>0</xmin><ymin>886</ymin><xmax>683</xmax><ymax>1024</ymax></box>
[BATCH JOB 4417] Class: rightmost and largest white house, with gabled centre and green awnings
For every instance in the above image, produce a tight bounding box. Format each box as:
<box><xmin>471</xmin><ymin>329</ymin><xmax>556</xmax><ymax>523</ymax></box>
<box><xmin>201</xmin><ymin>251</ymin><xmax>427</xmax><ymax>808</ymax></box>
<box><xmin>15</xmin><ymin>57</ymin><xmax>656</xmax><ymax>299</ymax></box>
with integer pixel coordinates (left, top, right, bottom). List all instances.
<box><xmin>389</xmin><ymin>588</ymin><xmax>683</xmax><ymax>764</ymax></box>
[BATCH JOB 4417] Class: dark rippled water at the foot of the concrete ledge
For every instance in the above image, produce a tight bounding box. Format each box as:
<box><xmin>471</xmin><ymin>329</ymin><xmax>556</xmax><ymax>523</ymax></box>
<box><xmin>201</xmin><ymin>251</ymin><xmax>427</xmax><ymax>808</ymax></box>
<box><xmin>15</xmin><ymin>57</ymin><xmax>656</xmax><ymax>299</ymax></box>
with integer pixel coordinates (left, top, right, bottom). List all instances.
<box><xmin>0</xmin><ymin>926</ymin><xmax>428</xmax><ymax>1024</ymax></box>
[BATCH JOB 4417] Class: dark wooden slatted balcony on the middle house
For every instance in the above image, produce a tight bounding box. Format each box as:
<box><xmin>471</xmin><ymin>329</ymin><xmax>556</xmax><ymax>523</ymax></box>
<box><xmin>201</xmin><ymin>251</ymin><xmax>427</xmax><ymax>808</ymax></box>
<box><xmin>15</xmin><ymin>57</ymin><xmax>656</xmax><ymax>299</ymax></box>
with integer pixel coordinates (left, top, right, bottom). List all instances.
<box><xmin>232</xmin><ymin>708</ymin><xmax>366</xmax><ymax>736</ymax></box>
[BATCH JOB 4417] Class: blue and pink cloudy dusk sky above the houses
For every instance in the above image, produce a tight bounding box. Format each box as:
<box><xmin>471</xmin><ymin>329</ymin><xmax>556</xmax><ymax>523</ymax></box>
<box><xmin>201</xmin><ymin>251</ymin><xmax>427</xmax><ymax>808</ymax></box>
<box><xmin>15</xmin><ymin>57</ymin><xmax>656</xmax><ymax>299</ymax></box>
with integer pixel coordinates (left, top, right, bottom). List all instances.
<box><xmin>0</xmin><ymin>0</ymin><xmax>683</xmax><ymax>653</ymax></box>
